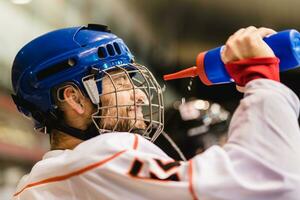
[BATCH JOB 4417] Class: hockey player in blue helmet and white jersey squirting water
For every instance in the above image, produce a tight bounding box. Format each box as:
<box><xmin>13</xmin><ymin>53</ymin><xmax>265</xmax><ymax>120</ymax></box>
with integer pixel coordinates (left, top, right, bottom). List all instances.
<box><xmin>12</xmin><ymin>25</ymin><xmax>300</xmax><ymax>200</ymax></box>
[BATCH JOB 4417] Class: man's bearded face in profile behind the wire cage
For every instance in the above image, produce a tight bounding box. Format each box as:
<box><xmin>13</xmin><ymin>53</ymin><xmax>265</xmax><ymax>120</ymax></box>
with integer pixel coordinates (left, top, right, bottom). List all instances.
<box><xmin>100</xmin><ymin>70</ymin><xmax>149</xmax><ymax>131</ymax></box>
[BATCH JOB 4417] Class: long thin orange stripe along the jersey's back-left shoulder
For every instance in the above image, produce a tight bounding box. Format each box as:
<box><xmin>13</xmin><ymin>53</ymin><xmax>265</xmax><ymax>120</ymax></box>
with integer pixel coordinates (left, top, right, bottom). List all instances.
<box><xmin>14</xmin><ymin>150</ymin><xmax>126</xmax><ymax>196</ymax></box>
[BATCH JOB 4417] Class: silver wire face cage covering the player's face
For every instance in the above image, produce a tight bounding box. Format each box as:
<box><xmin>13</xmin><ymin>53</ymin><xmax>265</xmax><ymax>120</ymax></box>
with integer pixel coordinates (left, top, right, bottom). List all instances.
<box><xmin>82</xmin><ymin>63</ymin><xmax>164</xmax><ymax>142</ymax></box>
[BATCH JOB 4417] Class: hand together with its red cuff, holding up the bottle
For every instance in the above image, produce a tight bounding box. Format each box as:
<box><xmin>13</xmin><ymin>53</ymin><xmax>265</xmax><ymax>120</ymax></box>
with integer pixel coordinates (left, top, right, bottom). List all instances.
<box><xmin>221</xmin><ymin>26</ymin><xmax>279</xmax><ymax>92</ymax></box>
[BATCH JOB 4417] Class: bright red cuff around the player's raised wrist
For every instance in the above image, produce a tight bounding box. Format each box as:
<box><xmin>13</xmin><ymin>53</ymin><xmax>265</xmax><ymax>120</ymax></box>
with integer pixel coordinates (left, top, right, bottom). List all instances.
<box><xmin>225</xmin><ymin>57</ymin><xmax>280</xmax><ymax>86</ymax></box>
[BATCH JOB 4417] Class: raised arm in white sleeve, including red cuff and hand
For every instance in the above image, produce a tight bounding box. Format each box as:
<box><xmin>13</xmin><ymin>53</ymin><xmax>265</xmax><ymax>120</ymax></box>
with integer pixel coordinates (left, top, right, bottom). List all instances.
<box><xmin>190</xmin><ymin>27</ymin><xmax>300</xmax><ymax>200</ymax></box>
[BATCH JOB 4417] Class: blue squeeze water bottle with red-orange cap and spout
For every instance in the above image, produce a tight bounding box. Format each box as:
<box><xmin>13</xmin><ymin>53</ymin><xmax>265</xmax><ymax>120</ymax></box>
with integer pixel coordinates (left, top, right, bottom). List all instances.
<box><xmin>164</xmin><ymin>29</ymin><xmax>300</xmax><ymax>85</ymax></box>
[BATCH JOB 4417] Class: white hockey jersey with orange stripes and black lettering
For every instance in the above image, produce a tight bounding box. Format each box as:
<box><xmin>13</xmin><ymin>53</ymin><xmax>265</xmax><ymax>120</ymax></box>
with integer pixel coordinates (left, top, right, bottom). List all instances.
<box><xmin>14</xmin><ymin>79</ymin><xmax>300</xmax><ymax>200</ymax></box>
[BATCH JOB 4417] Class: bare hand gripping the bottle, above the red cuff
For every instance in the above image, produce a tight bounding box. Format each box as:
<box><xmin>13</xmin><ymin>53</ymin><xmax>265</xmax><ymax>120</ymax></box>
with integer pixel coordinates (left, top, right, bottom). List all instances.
<box><xmin>221</xmin><ymin>26</ymin><xmax>276</xmax><ymax>64</ymax></box>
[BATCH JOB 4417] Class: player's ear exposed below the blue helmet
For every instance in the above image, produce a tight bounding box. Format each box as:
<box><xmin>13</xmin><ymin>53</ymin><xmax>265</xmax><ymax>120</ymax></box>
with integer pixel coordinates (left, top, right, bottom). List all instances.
<box><xmin>63</xmin><ymin>86</ymin><xmax>84</xmax><ymax>115</ymax></box>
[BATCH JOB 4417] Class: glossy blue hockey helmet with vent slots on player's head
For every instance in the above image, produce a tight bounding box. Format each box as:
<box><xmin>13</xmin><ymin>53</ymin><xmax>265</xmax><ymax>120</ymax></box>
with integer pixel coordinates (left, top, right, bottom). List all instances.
<box><xmin>12</xmin><ymin>24</ymin><xmax>163</xmax><ymax>139</ymax></box>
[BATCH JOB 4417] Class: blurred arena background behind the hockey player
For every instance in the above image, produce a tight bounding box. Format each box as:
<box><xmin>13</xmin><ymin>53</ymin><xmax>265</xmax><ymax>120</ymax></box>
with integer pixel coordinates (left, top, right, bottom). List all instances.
<box><xmin>0</xmin><ymin>0</ymin><xmax>300</xmax><ymax>200</ymax></box>
